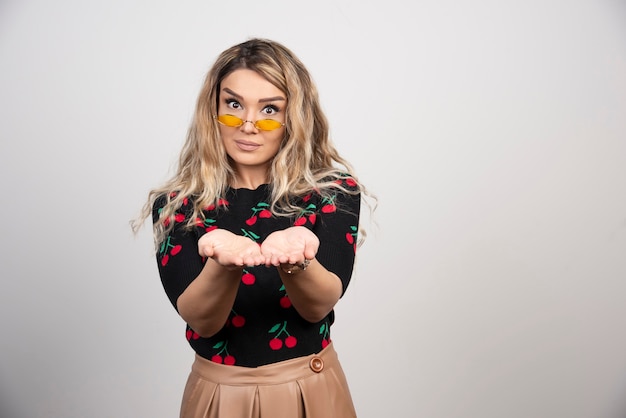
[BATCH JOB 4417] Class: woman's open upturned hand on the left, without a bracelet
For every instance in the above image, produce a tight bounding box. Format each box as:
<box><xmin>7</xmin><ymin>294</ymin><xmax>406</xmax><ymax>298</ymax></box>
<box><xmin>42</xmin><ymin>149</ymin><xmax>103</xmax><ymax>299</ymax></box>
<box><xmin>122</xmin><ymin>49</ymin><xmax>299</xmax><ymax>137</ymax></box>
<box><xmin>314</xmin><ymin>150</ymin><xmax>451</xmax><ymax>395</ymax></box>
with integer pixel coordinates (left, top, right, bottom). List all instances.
<box><xmin>198</xmin><ymin>229</ymin><xmax>265</xmax><ymax>269</ymax></box>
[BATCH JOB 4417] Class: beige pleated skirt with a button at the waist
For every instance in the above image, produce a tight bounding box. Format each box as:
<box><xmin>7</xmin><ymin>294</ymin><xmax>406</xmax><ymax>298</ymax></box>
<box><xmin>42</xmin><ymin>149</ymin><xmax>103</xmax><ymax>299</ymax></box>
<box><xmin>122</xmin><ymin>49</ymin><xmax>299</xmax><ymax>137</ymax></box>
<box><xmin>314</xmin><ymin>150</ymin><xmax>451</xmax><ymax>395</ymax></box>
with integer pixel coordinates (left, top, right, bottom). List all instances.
<box><xmin>180</xmin><ymin>343</ymin><xmax>356</xmax><ymax>418</ymax></box>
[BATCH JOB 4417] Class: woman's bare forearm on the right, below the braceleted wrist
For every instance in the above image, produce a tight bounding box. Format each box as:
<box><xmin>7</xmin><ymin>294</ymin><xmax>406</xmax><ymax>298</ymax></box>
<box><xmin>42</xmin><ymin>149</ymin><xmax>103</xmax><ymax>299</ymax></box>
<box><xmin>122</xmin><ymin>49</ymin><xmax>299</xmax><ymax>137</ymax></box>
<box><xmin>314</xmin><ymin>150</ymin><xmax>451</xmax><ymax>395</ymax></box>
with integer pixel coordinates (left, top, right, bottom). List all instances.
<box><xmin>277</xmin><ymin>259</ymin><xmax>342</xmax><ymax>322</ymax></box>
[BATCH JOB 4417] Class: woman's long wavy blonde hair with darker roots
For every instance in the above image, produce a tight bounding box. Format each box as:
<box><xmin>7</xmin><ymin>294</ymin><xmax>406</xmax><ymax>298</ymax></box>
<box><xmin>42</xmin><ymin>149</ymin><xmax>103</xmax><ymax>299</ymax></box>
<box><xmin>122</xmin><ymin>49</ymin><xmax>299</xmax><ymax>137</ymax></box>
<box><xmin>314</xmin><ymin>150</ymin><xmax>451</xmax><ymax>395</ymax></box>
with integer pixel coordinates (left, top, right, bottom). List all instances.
<box><xmin>131</xmin><ymin>38</ymin><xmax>371</xmax><ymax>246</ymax></box>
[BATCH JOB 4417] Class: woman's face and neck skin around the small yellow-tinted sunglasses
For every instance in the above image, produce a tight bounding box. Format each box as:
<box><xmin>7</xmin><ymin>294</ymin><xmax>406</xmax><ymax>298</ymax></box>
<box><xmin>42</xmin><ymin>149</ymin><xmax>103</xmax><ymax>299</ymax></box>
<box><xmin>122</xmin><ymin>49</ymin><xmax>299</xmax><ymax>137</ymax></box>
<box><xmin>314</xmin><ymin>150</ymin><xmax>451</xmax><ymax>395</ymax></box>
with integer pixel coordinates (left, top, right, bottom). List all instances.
<box><xmin>217</xmin><ymin>69</ymin><xmax>287</xmax><ymax>180</ymax></box>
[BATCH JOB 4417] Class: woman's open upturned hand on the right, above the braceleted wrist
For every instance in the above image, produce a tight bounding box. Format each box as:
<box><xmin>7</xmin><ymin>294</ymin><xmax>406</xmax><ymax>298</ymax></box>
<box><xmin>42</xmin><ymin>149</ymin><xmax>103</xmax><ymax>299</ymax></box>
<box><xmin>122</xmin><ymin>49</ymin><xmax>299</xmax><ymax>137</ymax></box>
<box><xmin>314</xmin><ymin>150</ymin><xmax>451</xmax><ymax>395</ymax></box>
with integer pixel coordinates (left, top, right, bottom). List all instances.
<box><xmin>261</xmin><ymin>226</ymin><xmax>320</xmax><ymax>266</ymax></box>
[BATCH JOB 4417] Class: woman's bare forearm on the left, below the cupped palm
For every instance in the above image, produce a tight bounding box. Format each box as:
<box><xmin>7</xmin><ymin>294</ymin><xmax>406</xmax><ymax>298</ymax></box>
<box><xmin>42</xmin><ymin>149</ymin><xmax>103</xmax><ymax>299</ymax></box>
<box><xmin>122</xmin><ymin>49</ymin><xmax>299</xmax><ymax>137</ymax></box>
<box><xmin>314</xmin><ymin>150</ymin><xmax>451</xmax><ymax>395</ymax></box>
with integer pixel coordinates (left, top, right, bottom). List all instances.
<box><xmin>177</xmin><ymin>258</ymin><xmax>242</xmax><ymax>338</ymax></box>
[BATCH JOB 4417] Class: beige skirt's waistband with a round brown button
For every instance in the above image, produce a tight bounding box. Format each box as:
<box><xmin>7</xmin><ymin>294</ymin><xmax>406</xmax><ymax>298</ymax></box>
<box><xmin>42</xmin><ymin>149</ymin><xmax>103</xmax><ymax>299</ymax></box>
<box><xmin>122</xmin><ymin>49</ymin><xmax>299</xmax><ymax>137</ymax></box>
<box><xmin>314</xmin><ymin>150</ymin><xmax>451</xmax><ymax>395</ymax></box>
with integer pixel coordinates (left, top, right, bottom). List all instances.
<box><xmin>191</xmin><ymin>342</ymin><xmax>340</xmax><ymax>386</ymax></box>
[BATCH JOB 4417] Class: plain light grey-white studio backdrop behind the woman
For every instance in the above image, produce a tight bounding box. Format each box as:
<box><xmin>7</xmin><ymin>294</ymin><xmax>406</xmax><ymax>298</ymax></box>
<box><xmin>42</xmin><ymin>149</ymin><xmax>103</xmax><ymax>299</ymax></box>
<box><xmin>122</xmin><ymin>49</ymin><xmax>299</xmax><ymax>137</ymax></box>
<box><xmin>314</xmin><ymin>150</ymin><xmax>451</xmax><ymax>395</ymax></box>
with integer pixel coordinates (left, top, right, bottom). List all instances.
<box><xmin>0</xmin><ymin>0</ymin><xmax>626</xmax><ymax>418</ymax></box>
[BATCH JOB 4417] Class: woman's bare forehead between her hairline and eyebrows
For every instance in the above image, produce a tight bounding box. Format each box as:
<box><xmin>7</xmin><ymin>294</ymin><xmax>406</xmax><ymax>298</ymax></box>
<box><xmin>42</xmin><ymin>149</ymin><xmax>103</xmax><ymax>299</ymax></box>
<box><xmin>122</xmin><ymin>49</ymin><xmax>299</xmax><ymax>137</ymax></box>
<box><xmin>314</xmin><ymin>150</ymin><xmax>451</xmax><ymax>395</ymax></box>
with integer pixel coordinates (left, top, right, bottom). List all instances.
<box><xmin>220</xmin><ymin>69</ymin><xmax>285</xmax><ymax>101</ymax></box>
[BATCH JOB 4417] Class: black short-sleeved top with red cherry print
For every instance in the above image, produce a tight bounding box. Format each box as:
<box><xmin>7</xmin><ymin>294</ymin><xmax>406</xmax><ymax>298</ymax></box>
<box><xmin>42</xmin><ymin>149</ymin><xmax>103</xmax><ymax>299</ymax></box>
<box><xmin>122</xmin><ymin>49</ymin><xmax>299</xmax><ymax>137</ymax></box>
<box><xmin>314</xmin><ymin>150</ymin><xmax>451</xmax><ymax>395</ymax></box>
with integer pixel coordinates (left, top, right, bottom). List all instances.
<box><xmin>153</xmin><ymin>178</ymin><xmax>360</xmax><ymax>367</ymax></box>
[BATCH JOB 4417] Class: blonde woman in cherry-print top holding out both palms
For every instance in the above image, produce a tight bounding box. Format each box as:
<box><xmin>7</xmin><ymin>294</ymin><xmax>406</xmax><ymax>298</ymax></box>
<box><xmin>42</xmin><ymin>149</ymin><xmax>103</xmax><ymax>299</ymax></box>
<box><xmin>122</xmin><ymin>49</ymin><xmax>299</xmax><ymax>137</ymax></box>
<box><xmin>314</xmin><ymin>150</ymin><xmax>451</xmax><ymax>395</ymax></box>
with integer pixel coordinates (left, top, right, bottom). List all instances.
<box><xmin>134</xmin><ymin>39</ymin><xmax>367</xmax><ymax>418</ymax></box>
